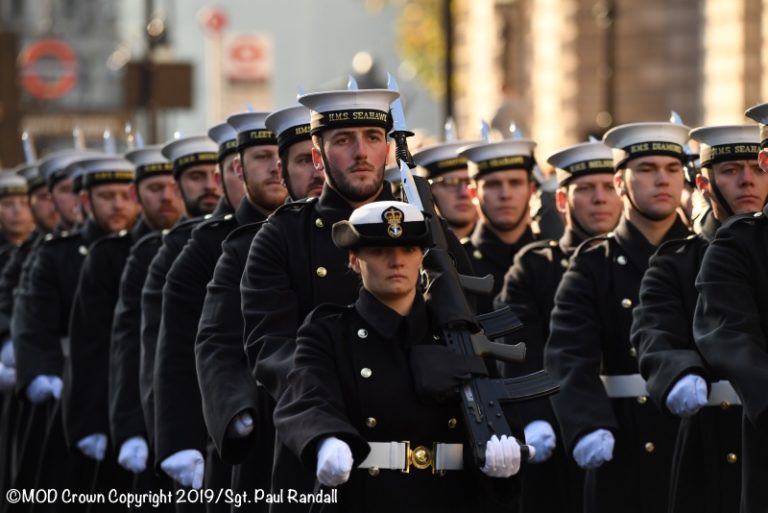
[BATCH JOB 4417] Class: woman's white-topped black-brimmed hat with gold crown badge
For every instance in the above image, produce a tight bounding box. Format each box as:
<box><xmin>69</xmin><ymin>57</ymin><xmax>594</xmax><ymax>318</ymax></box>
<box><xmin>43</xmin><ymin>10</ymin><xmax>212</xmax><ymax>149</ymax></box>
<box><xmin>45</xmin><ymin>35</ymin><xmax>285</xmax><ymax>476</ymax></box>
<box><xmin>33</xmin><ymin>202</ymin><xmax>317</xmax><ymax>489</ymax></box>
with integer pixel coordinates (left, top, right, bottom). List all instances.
<box><xmin>331</xmin><ymin>201</ymin><xmax>432</xmax><ymax>249</ymax></box>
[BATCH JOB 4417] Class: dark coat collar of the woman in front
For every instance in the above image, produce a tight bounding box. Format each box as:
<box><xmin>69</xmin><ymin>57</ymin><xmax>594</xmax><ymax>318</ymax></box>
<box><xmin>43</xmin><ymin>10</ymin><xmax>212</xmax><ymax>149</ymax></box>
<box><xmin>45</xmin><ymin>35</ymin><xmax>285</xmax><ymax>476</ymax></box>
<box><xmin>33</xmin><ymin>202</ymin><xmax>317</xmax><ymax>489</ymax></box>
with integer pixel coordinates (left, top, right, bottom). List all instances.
<box><xmin>355</xmin><ymin>288</ymin><xmax>429</xmax><ymax>343</ymax></box>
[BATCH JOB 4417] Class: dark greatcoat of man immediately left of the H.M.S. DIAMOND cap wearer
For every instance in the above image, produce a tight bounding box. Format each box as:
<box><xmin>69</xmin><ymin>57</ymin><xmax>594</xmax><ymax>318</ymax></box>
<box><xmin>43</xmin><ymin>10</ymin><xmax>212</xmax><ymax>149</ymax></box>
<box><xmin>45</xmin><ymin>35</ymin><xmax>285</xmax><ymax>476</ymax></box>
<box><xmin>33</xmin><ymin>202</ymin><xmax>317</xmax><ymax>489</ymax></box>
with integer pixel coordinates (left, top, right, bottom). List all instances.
<box><xmin>495</xmin><ymin>230</ymin><xmax>584</xmax><ymax>513</ymax></box>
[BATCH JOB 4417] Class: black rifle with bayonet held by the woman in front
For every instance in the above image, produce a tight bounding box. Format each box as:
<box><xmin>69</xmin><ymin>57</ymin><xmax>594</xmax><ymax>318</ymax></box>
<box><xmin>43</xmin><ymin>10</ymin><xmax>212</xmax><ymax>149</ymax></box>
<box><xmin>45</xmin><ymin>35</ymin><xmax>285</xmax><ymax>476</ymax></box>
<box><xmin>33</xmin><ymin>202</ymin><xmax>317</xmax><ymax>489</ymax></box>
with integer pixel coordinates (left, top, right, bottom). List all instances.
<box><xmin>387</xmin><ymin>76</ymin><xmax>558</xmax><ymax>468</ymax></box>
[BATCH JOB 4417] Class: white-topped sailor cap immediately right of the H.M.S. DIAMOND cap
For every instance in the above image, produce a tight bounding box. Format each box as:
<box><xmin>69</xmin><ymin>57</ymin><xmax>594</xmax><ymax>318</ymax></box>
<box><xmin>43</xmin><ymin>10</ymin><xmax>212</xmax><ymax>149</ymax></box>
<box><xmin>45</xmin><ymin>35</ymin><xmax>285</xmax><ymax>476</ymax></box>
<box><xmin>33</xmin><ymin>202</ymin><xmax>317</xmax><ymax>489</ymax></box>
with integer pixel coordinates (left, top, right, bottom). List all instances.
<box><xmin>690</xmin><ymin>125</ymin><xmax>760</xmax><ymax>167</ymax></box>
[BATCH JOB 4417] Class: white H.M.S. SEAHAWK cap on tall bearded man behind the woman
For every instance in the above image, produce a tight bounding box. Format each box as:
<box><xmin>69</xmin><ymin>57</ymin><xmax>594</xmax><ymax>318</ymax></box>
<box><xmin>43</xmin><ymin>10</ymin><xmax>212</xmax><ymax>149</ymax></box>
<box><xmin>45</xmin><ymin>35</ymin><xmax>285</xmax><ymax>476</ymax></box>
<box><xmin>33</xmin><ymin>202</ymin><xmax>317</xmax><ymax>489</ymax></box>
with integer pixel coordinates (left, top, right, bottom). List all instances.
<box><xmin>299</xmin><ymin>89</ymin><xmax>400</xmax><ymax>134</ymax></box>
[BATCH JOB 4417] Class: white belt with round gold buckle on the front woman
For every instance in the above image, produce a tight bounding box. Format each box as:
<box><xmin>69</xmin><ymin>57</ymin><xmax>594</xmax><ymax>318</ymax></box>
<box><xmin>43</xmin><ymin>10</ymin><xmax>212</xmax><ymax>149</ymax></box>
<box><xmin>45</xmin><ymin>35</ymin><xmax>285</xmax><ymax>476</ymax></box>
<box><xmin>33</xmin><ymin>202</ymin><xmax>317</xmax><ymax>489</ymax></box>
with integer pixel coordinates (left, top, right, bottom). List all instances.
<box><xmin>358</xmin><ymin>442</ymin><xmax>464</xmax><ymax>474</ymax></box>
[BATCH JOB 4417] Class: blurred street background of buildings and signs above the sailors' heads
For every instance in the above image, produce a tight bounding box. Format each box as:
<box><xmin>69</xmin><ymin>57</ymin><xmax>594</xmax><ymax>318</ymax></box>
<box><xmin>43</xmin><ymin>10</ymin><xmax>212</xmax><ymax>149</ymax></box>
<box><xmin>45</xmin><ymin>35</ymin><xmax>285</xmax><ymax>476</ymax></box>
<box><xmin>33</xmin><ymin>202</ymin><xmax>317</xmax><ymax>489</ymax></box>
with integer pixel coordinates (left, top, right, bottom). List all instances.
<box><xmin>0</xmin><ymin>0</ymin><xmax>768</xmax><ymax>167</ymax></box>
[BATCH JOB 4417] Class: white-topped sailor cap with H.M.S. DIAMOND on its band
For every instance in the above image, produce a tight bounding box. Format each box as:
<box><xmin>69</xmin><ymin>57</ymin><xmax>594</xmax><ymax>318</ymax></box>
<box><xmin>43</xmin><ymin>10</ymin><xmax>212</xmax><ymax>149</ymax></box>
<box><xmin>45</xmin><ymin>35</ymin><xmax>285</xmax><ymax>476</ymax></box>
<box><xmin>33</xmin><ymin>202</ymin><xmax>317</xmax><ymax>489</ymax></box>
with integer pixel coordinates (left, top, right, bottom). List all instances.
<box><xmin>603</xmin><ymin>121</ymin><xmax>691</xmax><ymax>169</ymax></box>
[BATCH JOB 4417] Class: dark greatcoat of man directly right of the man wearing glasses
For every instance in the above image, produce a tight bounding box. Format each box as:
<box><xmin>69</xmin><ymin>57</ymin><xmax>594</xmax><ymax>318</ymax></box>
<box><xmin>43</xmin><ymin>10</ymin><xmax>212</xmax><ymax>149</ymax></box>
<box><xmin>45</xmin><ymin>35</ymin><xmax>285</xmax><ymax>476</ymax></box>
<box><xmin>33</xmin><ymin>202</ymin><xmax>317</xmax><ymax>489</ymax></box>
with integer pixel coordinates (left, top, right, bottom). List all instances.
<box><xmin>463</xmin><ymin>222</ymin><xmax>536</xmax><ymax>314</ymax></box>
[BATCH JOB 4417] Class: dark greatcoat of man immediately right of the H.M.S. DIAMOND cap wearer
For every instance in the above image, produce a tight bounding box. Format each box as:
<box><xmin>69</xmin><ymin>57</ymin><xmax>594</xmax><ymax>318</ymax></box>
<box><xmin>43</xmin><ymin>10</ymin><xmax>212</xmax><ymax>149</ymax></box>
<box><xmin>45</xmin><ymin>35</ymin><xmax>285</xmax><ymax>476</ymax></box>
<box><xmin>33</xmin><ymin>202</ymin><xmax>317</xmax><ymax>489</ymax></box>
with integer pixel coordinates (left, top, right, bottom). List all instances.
<box><xmin>631</xmin><ymin>216</ymin><xmax>741</xmax><ymax>513</ymax></box>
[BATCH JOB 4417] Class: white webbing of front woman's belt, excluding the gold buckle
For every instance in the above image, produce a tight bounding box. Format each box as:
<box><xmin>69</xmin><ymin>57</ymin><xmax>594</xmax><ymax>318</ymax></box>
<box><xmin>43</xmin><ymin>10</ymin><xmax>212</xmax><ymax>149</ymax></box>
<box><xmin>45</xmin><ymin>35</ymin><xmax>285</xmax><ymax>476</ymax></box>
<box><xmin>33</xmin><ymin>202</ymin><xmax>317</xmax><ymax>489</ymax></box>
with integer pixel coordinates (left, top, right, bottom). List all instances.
<box><xmin>358</xmin><ymin>442</ymin><xmax>464</xmax><ymax>471</ymax></box>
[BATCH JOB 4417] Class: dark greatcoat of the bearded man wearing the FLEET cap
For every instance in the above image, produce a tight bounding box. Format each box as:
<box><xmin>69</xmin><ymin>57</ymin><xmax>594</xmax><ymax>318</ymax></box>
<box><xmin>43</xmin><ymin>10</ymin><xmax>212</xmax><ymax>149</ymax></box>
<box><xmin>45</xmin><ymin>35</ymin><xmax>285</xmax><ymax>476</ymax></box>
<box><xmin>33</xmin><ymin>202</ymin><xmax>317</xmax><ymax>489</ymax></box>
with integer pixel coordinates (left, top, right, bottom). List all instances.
<box><xmin>154</xmin><ymin>198</ymin><xmax>265</xmax><ymax>510</ymax></box>
